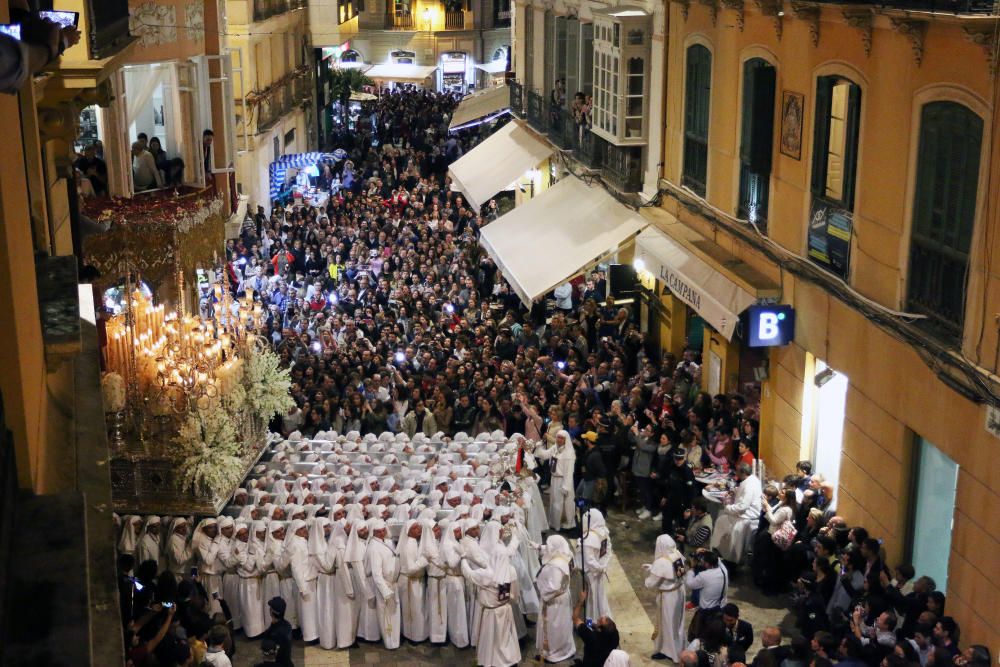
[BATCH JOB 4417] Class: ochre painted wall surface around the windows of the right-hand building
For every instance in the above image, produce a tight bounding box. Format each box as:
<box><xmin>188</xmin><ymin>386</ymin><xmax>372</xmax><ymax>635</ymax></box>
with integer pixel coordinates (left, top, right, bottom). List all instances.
<box><xmin>663</xmin><ymin>3</ymin><xmax>1000</xmax><ymax>650</ymax></box>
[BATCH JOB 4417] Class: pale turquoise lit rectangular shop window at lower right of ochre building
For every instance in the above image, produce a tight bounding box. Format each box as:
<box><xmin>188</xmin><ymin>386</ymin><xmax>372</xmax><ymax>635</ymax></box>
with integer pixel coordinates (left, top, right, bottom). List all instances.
<box><xmin>910</xmin><ymin>436</ymin><xmax>958</xmax><ymax>592</ymax></box>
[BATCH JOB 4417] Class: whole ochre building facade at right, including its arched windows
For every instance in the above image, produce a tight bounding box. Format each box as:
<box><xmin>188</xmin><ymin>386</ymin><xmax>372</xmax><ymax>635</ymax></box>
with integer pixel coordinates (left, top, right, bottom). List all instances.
<box><xmin>648</xmin><ymin>0</ymin><xmax>1000</xmax><ymax>649</ymax></box>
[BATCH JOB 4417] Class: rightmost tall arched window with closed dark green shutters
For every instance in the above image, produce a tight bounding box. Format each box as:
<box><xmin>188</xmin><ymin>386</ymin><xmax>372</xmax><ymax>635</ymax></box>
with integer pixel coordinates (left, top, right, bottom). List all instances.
<box><xmin>907</xmin><ymin>102</ymin><xmax>983</xmax><ymax>338</ymax></box>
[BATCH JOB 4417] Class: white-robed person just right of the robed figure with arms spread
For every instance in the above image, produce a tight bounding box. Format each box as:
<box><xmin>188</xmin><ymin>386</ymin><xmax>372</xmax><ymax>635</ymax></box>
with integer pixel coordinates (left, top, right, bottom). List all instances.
<box><xmin>535</xmin><ymin>535</ymin><xmax>576</xmax><ymax>662</ymax></box>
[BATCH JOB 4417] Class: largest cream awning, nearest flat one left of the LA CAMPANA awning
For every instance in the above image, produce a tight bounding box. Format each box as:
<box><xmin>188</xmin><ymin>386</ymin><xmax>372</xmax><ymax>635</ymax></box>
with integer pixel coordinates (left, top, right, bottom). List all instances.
<box><xmin>479</xmin><ymin>176</ymin><xmax>647</xmax><ymax>305</ymax></box>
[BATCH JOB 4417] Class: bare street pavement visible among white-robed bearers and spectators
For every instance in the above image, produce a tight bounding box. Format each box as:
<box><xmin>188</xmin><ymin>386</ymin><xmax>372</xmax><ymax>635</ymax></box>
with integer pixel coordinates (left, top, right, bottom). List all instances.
<box><xmin>233</xmin><ymin>508</ymin><xmax>792</xmax><ymax>667</ymax></box>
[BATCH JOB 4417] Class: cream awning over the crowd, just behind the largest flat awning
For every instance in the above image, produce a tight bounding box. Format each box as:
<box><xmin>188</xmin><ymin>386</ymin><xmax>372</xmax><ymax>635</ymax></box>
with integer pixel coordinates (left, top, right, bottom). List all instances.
<box><xmin>448</xmin><ymin>121</ymin><xmax>553</xmax><ymax>211</ymax></box>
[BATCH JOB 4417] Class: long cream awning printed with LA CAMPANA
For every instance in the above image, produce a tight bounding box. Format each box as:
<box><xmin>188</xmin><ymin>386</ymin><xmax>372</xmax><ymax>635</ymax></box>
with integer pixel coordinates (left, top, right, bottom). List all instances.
<box><xmin>635</xmin><ymin>227</ymin><xmax>757</xmax><ymax>340</ymax></box>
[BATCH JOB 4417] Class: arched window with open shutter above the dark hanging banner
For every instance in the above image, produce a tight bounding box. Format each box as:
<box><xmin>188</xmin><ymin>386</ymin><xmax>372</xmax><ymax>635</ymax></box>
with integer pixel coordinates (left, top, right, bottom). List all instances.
<box><xmin>812</xmin><ymin>76</ymin><xmax>861</xmax><ymax>211</ymax></box>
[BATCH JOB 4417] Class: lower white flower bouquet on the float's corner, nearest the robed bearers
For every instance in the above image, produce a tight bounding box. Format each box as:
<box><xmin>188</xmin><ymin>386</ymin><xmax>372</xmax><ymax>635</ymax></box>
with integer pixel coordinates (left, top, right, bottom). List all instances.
<box><xmin>174</xmin><ymin>409</ymin><xmax>243</xmax><ymax>497</ymax></box>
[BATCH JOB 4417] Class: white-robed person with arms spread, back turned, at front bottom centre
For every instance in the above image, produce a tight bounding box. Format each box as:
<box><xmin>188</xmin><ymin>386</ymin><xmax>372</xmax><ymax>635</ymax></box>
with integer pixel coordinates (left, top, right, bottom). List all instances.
<box><xmin>462</xmin><ymin>550</ymin><xmax>521</xmax><ymax>667</ymax></box>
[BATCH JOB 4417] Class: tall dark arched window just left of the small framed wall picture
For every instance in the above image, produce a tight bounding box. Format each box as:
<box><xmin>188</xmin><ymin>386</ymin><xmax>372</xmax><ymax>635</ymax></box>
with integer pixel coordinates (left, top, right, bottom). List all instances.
<box><xmin>737</xmin><ymin>58</ymin><xmax>776</xmax><ymax>227</ymax></box>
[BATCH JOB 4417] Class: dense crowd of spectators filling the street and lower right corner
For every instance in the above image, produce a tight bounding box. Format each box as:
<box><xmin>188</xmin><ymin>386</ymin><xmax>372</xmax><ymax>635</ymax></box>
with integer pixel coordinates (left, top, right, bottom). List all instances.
<box><xmin>197</xmin><ymin>91</ymin><xmax>989</xmax><ymax>667</ymax></box>
